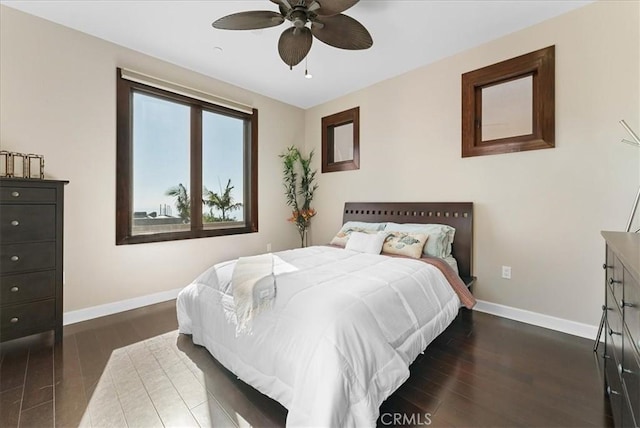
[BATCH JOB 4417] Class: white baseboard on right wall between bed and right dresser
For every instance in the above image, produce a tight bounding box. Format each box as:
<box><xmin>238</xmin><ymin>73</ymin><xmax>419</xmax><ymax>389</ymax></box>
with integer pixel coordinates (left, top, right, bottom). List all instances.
<box><xmin>473</xmin><ymin>300</ymin><xmax>604</xmax><ymax>340</ymax></box>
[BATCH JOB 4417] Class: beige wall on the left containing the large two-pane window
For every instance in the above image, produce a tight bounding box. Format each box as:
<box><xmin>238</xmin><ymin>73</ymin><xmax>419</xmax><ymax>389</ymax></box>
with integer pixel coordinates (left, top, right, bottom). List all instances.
<box><xmin>0</xmin><ymin>6</ymin><xmax>304</xmax><ymax>312</ymax></box>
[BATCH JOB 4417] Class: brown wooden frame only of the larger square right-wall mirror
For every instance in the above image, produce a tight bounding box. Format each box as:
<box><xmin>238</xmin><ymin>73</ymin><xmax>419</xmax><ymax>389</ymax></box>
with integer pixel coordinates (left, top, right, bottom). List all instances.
<box><xmin>462</xmin><ymin>46</ymin><xmax>555</xmax><ymax>158</ymax></box>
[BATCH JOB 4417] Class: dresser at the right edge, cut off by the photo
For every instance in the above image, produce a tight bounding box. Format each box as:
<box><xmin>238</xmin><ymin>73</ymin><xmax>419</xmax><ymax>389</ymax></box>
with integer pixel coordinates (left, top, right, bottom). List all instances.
<box><xmin>602</xmin><ymin>232</ymin><xmax>640</xmax><ymax>427</ymax></box>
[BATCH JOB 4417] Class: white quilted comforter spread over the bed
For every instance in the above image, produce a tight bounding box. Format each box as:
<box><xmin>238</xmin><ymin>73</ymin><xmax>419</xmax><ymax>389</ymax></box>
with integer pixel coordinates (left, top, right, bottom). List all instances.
<box><xmin>177</xmin><ymin>247</ymin><xmax>460</xmax><ymax>427</ymax></box>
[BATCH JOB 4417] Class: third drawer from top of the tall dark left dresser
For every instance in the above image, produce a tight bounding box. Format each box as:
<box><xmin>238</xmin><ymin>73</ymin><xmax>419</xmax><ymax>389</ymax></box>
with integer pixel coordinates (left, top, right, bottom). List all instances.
<box><xmin>0</xmin><ymin>242</ymin><xmax>56</xmax><ymax>274</ymax></box>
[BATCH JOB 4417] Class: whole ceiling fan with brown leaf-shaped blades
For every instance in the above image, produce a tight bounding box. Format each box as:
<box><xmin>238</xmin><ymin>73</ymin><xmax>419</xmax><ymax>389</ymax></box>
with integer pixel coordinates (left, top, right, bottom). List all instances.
<box><xmin>212</xmin><ymin>0</ymin><xmax>373</xmax><ymax>68</ymax></box>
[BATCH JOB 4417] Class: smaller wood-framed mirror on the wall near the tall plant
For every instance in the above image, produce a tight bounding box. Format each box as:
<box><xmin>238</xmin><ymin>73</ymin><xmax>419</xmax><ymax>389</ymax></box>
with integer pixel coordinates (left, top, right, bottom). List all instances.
<box><xmin>322</xmin><ymin>107</ymin><xmax>360</xmax><ymax>172</ymax></box>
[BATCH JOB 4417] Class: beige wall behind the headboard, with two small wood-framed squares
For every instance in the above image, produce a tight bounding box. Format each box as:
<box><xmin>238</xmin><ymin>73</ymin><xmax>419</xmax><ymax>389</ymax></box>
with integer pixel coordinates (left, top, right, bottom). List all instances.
<box><xmin>306</xmin><ymin>2</ymin><xmax>640</xmax><ymax>325</ymax></box>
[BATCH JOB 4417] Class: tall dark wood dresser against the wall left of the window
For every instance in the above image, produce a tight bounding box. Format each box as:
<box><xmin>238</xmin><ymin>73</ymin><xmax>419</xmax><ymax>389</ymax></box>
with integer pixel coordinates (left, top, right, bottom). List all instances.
<box><xmin>0</xmin><ymin>178</ymin><xmax>67</xmax><ymax>342</ymax></box>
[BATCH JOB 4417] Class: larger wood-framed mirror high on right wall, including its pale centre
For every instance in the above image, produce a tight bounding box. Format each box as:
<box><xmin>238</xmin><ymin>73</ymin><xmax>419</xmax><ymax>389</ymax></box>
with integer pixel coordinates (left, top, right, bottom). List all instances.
<box><xmin>462</xmin><ymin>46</ymin><xmax>555</xmax><ymax>157</ymax></box>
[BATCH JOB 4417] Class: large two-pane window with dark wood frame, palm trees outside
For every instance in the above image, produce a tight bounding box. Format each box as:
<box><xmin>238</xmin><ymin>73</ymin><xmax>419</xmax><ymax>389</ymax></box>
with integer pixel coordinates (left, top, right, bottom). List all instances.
<box><xmin>116</xmin><ymin>69</ymin><xmax>258</xmax><ymax>245</ymax></box>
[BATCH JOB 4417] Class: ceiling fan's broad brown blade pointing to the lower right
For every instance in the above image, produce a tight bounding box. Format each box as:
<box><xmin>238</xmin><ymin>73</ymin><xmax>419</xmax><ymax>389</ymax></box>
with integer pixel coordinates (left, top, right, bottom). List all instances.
<box><xmin>311</xmin><ymin>14</ymin><xmax>373</xmax><ymax>50</ymax></box>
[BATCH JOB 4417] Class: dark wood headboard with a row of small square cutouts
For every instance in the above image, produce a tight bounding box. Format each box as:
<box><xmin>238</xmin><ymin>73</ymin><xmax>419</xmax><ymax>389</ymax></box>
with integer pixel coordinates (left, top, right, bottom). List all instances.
<box><xmin>342</xmin><ymin>202</ymin><xmax>473</xmax><ymax>279</ymax></box>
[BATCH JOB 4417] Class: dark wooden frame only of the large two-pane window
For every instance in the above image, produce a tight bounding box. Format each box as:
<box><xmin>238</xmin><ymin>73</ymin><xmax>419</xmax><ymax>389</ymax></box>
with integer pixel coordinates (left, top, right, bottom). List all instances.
<box><xmin>116</xmin><ymin>68</ymin><xmax>258</xmax><ymax>245</ymax></box>
